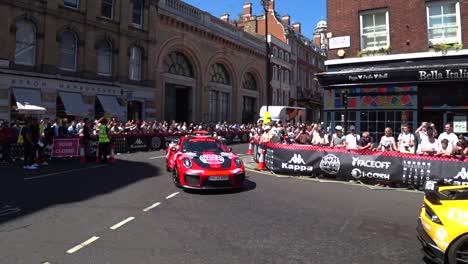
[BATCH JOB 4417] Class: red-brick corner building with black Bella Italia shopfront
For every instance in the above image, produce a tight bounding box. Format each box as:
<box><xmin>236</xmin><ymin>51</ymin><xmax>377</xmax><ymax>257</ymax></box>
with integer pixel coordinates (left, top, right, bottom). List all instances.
<box><xmin>319</xmin><ymin>0</ymin><xmax>468</xmax><ymax>138</ymax></box>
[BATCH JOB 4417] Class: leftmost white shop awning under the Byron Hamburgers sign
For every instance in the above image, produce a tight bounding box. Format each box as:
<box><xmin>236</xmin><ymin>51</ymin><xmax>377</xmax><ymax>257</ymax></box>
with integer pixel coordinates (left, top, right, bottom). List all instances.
<box><xmin>13</xmin><ymin>88</ymin><xmax>46</xmax><ymax>114</ymax></box>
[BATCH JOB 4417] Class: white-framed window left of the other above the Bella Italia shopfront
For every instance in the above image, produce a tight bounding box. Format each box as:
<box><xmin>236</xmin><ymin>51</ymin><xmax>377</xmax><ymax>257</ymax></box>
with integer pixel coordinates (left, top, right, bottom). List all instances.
<box><xmin>360</xmin><ymin>10</ymin><xmax>390</xmax><ymax>50</ymax></box>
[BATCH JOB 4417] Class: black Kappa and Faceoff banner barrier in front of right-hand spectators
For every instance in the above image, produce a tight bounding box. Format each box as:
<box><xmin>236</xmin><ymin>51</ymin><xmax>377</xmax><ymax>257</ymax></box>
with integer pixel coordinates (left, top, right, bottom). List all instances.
<box><xmin>253</xmin><ymin>141</ymin><xmax>468</xmax><ymax>188</ymax></box>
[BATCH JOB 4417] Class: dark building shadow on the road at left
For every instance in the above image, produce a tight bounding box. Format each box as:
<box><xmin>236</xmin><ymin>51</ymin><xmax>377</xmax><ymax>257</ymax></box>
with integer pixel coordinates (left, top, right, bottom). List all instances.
<box><xmin>0</xmin><ymin>160</ymin><xmax>160</xmax><ymax>223</ymax></box>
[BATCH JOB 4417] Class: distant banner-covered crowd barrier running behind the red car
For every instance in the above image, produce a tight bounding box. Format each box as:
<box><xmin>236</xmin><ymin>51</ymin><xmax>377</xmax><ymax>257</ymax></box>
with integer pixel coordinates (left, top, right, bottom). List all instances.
<box><xmin>0</xmin><ymin>130</ymin><xmax>250</xmax><ymax>160</ymax></box>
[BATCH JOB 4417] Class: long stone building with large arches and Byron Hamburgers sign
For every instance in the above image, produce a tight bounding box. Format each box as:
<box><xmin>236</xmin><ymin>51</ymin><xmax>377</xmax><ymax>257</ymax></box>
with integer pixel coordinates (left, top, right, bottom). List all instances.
<box><xmin>0</xmin><ymin>0</ymin><xmax>266</xmax><ymax>122</ymax></box>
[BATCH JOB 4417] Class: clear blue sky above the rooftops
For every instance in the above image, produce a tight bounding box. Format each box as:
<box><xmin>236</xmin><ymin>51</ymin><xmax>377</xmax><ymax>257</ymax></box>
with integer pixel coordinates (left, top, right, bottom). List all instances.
<box><xmin>183</xmin><ymin>0</ymin><xmax>327</xmax><ymax>38</ymax></box>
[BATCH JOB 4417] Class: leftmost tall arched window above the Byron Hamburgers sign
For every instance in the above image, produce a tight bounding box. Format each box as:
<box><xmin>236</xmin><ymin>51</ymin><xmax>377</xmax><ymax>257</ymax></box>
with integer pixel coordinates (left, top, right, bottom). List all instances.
<box><xmin>15</xmin><ymin>20</ymin><xmax>36</xmax><ymax>65</ymax></box>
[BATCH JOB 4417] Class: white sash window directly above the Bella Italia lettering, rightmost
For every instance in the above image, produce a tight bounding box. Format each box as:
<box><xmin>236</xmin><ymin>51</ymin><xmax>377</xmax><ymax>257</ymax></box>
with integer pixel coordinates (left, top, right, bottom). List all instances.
<box><xmin>427</xmin><ymin>2</ymin><xmax>461</xmax><ymax>45</ymax></box>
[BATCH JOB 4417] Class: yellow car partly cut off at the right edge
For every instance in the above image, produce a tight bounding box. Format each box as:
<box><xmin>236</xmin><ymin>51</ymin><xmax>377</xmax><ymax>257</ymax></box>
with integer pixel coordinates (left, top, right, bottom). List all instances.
<box><xmin>417</xmin><ymin>181</ymin><xmax>468</xmax><ymax>264</ymax></box>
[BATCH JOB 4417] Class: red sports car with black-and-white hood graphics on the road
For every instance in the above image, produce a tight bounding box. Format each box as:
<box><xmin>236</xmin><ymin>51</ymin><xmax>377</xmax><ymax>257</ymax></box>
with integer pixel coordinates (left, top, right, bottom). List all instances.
<box><xmin>167</xmin><ymin>135</ymin><xmax>245</xmax><ymax>189</ymax></box>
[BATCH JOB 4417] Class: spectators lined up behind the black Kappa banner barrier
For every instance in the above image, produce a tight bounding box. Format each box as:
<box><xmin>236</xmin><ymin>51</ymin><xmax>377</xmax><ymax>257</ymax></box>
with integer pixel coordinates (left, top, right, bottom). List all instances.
<box><xmin>252</xmin><ymin>122</ymin><xmax>468</xmax><ymax>159</ymax></box>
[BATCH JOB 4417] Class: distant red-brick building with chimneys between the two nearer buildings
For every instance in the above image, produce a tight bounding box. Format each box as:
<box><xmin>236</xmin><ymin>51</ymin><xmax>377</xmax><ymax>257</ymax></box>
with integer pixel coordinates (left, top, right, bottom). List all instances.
<box><xmin>236</xmin><ymin>1</ymin><xmax>326</xmax><ymax>122</ymax></box>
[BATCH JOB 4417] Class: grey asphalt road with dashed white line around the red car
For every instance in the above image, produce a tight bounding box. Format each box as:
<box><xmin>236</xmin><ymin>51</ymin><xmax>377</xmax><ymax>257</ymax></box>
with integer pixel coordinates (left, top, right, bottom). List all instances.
<box><xmin>0</xmin><ymin>145</ymin><xmax>423</xmax><ymax>264</ymax></box>
